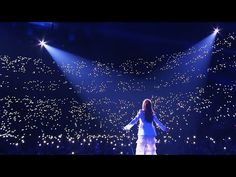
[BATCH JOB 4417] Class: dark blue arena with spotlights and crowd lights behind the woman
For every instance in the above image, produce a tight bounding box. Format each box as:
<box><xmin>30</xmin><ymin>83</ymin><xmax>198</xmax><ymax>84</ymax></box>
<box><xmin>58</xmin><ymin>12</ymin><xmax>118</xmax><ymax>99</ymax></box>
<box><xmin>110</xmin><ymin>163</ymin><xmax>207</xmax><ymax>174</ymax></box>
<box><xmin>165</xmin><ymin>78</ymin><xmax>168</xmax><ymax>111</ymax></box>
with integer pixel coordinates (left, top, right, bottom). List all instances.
<box><xmin>0</xmin><ymin>22</ymin><xmax>236</xmax><ymax>155</ymax></box>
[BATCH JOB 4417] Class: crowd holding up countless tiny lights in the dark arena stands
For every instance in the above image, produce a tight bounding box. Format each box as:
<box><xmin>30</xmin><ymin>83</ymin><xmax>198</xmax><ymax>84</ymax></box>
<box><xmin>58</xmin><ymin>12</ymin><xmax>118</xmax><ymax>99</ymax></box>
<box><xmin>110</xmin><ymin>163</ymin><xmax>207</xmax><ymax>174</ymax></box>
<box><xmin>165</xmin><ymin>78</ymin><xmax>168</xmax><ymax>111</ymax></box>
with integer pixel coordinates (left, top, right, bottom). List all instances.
<box><xmin>0</xmin><ymin>33</ymin><xmax>236</xmax><ymax>154</ymax></box>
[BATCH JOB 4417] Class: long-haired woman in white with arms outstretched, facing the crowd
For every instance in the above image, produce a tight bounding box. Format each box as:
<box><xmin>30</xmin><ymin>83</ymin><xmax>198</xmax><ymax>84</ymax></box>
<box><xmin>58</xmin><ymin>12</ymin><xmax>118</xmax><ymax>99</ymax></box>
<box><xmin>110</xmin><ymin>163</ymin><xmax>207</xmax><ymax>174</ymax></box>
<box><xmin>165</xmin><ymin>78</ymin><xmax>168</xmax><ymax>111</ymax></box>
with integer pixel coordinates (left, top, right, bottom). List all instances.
<box><xmin>124</xmin><ymin>99</ymin><xmax>167</xmax><ymax>155</ymax></box>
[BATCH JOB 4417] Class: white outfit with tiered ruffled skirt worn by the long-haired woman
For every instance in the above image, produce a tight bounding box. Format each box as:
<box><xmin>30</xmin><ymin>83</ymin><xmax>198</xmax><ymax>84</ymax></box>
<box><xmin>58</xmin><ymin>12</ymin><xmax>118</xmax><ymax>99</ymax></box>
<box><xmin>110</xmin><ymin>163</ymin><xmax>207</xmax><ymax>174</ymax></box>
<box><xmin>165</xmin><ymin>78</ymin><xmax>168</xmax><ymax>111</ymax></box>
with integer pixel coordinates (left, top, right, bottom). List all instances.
<box><xmin>124</xmin><ymin>110</ymin><xmax>166</xmax><ymax>155</ymax></box>
